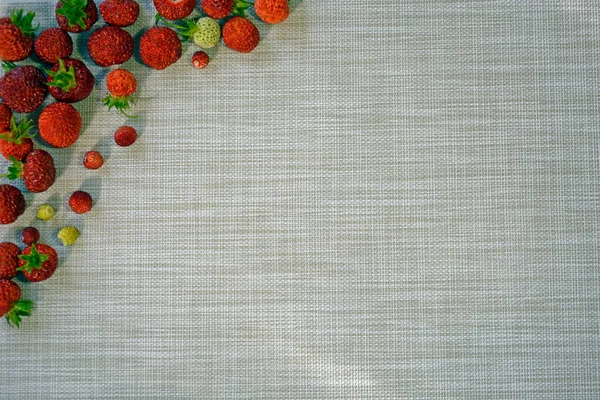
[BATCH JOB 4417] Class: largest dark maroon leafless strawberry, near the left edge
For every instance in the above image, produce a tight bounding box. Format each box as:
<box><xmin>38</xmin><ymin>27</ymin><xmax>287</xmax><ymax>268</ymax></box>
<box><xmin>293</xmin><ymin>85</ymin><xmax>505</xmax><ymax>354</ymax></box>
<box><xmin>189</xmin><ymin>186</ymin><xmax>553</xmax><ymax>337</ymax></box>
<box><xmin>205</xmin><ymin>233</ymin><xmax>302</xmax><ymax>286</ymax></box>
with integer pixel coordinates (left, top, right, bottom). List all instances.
<box><xmin>0</xmin><ymin>65</ymin><xmax>47</xmax><ymax>113</ymax></box>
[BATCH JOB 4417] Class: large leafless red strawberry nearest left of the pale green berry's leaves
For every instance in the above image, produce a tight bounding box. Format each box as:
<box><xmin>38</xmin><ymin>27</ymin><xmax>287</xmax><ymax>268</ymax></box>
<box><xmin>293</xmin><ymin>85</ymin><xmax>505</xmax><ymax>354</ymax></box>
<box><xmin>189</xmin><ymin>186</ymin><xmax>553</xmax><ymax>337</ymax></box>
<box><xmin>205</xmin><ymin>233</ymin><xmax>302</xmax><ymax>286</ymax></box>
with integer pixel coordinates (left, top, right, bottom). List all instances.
<box><xmin>140</xmin><ymin>26</ymin><xmax>181</xmax><ymax>70</ymax></box>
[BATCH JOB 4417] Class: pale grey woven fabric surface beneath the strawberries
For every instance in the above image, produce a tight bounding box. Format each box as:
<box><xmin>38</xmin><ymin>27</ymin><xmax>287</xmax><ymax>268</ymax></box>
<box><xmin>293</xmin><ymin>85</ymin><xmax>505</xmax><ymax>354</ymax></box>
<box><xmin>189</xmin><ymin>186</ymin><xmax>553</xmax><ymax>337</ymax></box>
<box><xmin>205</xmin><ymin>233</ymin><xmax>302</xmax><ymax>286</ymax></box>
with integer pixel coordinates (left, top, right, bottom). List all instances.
<box><xmin>0</xmin><ymin>0</ymin><xmax>600</xmax><ymax>399</ymax></box>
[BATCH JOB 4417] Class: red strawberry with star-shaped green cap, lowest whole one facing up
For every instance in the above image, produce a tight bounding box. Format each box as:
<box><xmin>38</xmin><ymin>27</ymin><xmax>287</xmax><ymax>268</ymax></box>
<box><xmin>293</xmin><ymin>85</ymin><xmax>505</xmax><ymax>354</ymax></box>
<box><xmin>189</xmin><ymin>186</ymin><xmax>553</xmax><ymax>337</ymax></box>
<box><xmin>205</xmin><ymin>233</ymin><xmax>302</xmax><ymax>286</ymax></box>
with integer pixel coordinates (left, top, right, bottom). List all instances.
<box><xmin>17</xmin><ymin>243</ymin><xmax>58</xmax><ymax>282</ymax></box>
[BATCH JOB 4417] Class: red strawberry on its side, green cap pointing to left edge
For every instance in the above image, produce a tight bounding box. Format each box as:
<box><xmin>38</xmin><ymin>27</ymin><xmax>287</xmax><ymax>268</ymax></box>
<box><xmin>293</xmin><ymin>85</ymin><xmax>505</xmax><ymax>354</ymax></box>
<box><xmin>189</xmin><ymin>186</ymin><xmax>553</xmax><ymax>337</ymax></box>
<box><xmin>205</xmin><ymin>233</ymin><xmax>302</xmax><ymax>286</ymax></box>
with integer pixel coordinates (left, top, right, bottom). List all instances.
<box><xmin>2</xmin><ymin>150</ymin><xmax>56</xmax><ymax>193</ymax></box>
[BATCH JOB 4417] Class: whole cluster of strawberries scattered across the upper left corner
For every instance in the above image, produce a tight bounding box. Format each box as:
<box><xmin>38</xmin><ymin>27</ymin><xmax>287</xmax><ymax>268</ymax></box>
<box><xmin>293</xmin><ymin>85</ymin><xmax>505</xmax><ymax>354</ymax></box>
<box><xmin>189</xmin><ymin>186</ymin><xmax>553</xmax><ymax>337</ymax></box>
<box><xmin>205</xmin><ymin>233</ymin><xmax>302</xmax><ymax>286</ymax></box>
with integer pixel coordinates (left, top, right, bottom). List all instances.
<box><xmin>0</xmin><ymin>0</ymin><xmax>290</xmax><ymax>327</ymax></box>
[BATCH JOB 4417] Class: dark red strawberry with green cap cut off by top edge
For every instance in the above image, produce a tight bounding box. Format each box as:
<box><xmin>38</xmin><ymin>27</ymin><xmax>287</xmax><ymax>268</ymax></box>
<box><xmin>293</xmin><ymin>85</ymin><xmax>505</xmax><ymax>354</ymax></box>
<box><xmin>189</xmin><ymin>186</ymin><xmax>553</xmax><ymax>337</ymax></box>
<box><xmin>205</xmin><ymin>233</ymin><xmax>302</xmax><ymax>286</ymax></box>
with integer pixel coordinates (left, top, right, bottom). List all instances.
<box><xmin>55</xmin><ymin>0</ymin><xmax>98</xmax><ymax>33</ymax></box>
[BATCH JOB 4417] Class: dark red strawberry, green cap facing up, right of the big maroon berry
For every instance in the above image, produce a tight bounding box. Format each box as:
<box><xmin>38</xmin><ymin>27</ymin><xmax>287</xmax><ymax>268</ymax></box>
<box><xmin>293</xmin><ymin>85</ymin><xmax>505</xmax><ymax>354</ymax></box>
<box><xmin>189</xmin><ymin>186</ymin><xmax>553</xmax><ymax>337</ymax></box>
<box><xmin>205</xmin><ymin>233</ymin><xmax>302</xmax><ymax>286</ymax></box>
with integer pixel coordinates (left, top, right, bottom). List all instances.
<box><xmin>46</xmin><ymin>58</ymin><xmax>96</xmax><ymax>103</ymax></box>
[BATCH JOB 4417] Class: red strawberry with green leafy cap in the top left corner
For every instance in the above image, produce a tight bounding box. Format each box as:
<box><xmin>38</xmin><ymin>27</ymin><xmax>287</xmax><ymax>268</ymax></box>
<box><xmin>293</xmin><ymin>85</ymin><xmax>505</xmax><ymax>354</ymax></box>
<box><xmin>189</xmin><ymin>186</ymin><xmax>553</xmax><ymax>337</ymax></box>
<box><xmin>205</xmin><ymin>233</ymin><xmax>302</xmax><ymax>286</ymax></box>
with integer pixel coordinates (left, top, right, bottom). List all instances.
<box><xmin>0</xmin><ymin>10</ymin><xmax>39</xmax><ymax>62</ymax></box>
